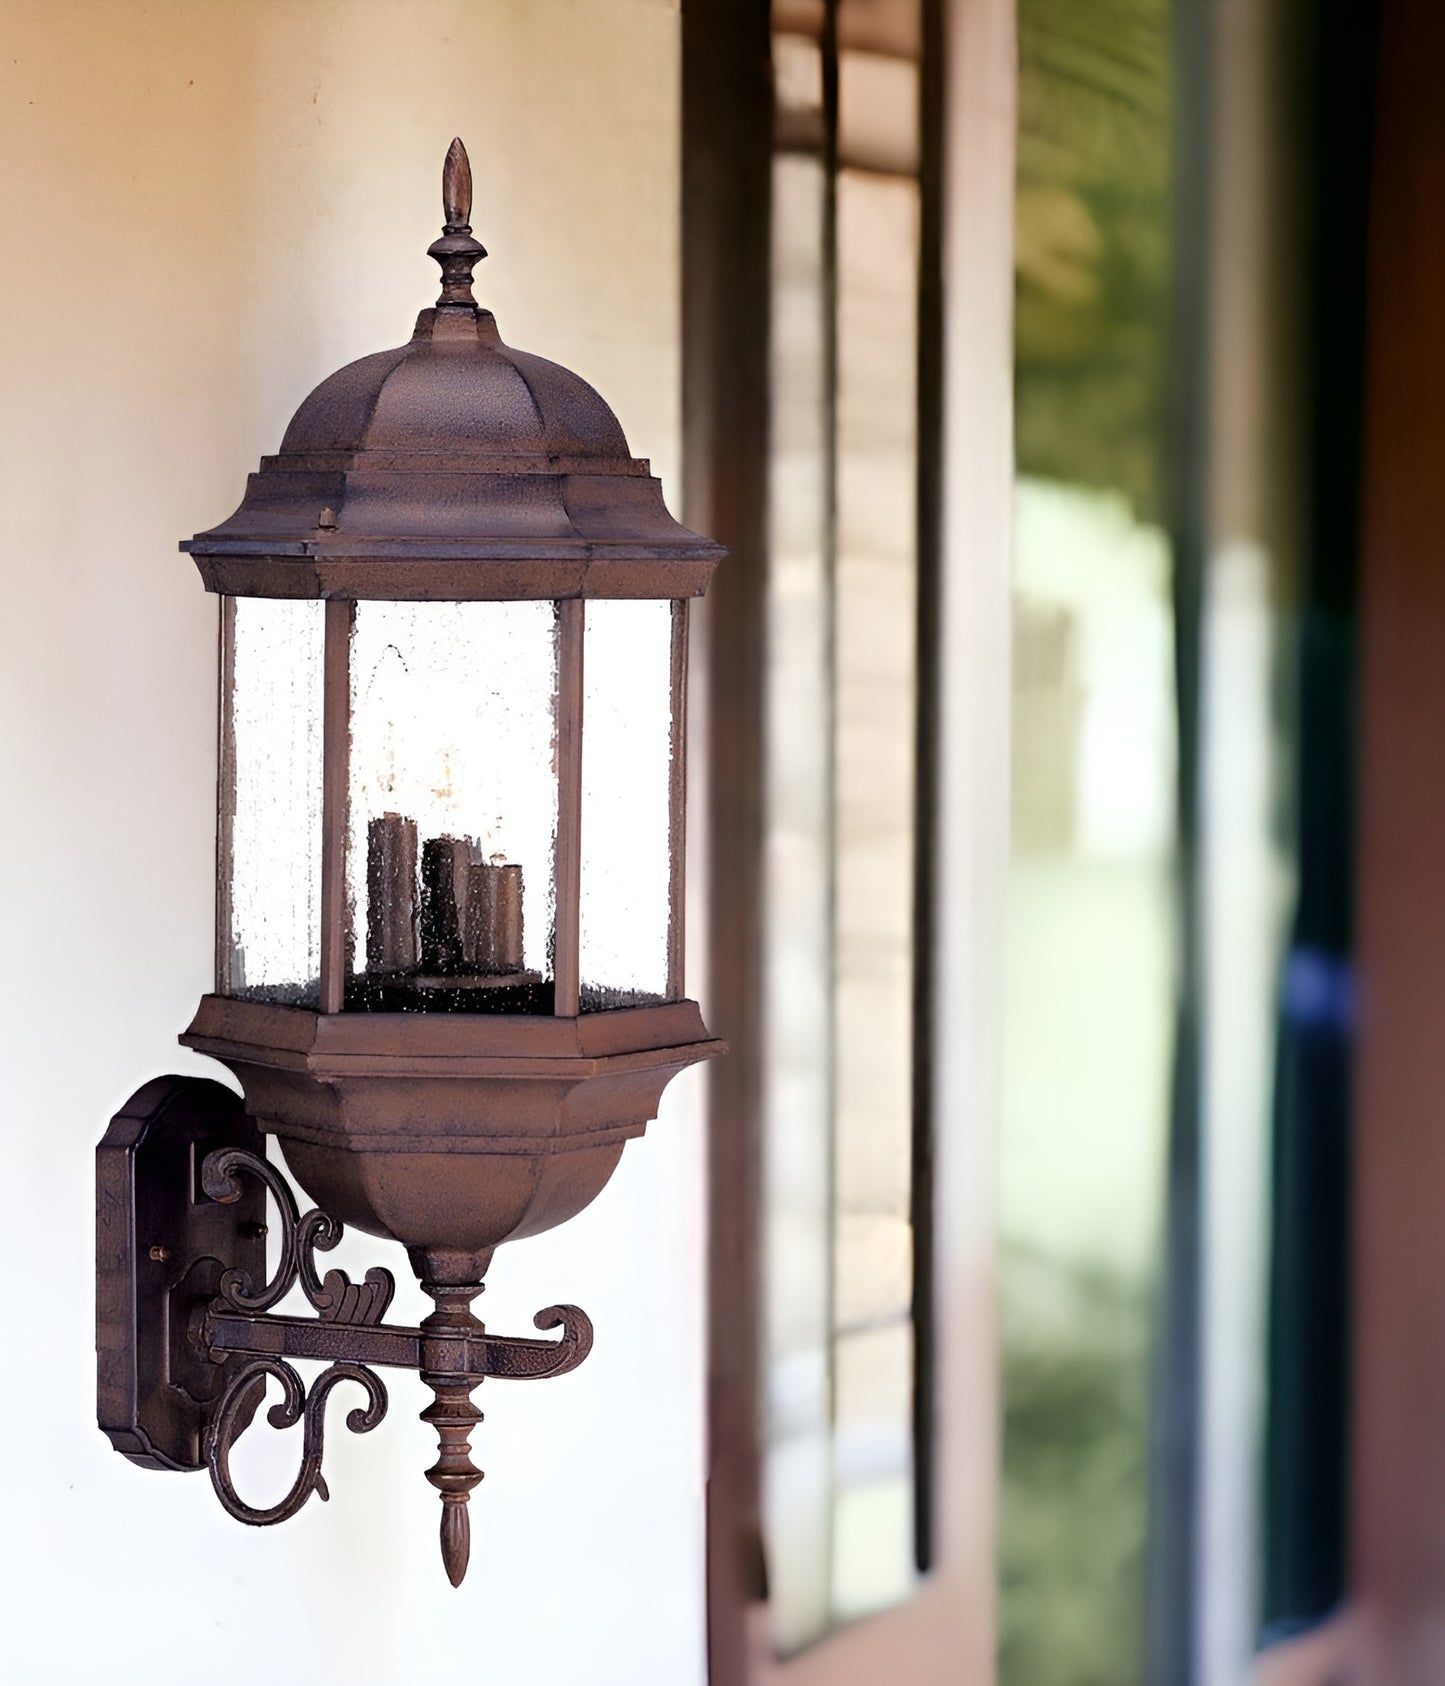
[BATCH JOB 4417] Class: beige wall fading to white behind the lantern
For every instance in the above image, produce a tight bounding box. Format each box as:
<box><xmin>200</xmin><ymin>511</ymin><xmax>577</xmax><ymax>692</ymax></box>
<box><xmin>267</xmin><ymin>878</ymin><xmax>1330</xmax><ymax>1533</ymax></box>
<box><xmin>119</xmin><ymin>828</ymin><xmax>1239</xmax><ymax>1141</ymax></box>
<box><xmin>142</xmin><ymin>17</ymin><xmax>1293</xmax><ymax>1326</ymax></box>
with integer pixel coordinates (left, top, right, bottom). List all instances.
<box><xmin>0</xmin><ymin>0</ymin><xmax>705</xmax><ymax>1686</ymax></box>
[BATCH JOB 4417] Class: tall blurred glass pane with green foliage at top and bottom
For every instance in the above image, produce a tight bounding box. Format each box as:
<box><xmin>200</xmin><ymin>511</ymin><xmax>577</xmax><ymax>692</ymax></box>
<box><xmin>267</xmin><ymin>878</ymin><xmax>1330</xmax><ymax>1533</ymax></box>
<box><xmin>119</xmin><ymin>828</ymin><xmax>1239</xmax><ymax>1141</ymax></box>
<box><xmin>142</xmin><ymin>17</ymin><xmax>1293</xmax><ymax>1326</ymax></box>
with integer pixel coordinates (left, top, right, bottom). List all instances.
<box><xmin>998</xmin><ymin>0</ymin><xmax>1173</xmax><ymax>1686</ymax></box>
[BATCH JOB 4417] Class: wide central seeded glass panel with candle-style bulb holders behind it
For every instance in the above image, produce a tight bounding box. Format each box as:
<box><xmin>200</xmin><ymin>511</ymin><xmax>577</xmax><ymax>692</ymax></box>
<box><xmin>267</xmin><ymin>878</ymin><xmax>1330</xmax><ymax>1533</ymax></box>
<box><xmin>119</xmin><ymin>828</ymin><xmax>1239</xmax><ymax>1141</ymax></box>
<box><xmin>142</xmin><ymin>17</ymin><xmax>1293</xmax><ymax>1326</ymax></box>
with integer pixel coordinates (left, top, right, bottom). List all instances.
<box><xmin>346</xmin><ymin>602</ymin><xmax>556</xmax><ymax>1013</ymax></box>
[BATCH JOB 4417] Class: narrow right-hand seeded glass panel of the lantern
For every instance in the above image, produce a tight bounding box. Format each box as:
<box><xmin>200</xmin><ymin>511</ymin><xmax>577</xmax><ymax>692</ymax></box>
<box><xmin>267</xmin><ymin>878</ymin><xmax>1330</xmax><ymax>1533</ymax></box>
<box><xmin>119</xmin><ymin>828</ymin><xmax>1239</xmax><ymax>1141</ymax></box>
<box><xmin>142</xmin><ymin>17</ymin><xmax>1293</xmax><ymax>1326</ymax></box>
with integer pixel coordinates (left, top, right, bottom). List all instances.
<box><xmin>578</xmin><ymin>600</ymin><xmax>673</xmax><ymax>1012</ymax></box>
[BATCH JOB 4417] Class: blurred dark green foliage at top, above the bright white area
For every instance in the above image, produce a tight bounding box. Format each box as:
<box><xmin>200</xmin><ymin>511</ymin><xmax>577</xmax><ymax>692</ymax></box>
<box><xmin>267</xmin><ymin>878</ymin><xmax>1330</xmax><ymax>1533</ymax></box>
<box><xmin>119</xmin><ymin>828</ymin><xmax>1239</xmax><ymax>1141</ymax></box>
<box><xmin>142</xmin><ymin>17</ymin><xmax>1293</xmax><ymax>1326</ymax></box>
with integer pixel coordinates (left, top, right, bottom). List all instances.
<box><xmin>1015</xmin><ymin>0</ymin><xmax>1170</xmax><ymax>521</ymax></box>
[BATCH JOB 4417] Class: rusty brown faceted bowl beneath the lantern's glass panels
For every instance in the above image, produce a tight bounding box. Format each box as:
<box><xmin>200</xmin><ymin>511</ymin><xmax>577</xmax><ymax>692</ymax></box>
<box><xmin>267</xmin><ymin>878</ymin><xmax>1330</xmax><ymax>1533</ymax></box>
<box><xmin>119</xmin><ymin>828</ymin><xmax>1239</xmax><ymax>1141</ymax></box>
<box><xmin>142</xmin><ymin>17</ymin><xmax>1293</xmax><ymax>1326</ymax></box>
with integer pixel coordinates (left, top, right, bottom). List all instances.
<box><xmin>180</xmin><ymin>995</ymin><xmax>723</xmax><ymax>1271</ymax></box>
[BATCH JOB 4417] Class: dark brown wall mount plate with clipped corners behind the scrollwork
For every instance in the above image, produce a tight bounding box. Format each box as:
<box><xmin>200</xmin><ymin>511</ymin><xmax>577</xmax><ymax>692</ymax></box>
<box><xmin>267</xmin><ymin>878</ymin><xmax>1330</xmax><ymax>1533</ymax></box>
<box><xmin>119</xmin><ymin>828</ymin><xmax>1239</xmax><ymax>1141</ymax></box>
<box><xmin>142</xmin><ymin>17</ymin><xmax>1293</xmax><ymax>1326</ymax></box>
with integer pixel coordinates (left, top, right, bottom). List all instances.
<box><xmin>96</xmin><ymin>1077</ymin><xmax>266</xmax><ymax>1470</ymax></box>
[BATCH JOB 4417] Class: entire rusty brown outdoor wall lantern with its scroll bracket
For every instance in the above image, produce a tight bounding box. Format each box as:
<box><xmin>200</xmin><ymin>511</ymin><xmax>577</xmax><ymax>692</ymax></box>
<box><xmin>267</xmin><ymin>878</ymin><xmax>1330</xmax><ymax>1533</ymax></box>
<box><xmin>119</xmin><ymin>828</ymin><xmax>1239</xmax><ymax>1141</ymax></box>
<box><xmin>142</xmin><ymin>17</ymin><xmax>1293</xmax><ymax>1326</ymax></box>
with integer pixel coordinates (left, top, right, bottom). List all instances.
<box><xmin>96</xmin><ymin>140</ymin><xmax>722</xmax><ymax>1585</ymax></box>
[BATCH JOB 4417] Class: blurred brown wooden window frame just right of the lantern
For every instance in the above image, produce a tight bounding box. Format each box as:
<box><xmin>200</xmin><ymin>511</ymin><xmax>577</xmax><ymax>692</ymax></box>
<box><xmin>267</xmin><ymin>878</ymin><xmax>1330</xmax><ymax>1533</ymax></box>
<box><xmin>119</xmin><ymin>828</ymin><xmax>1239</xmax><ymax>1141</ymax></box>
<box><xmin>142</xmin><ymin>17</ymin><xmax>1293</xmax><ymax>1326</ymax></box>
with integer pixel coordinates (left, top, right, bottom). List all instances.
<box><xmin>681</xmin><ymin>0</ymin><xmax>1017</xmax><ymax>1686</ymax></box>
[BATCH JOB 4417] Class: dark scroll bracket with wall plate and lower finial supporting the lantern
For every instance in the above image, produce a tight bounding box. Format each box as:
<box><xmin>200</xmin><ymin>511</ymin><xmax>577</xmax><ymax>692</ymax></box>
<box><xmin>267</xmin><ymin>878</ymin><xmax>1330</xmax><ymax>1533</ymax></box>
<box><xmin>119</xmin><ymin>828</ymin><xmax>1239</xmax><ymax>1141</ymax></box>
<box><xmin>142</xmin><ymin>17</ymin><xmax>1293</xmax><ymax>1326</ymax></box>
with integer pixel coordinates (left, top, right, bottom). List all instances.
<box><xmin>96</xmin><ymin>1077</ymin><xmax>592</xmax><ymax>1587</ymax></box>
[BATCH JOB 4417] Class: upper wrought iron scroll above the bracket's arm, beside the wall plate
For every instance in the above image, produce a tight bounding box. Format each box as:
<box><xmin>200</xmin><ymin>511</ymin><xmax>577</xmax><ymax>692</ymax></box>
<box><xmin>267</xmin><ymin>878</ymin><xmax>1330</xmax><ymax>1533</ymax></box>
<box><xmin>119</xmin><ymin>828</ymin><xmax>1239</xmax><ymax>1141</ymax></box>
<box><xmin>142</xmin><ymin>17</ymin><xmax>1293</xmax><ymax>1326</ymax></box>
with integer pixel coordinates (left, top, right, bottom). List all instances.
<box><xmin>201</xmin><ymin>1148</ymin><xmax>396</xmax><ymax>1324</ymax></box>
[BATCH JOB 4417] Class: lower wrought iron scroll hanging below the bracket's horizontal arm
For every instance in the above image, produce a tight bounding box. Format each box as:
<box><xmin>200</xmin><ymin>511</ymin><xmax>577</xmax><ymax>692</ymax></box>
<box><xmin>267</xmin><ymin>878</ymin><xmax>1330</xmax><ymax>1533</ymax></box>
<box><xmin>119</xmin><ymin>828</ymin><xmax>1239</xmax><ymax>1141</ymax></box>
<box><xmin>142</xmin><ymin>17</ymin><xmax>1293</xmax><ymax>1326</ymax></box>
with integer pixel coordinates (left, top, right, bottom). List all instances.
<box><xmin>206</xmin><ymin>1357</ymin><xmax>386</xmax><ymax>1528</ymax></box>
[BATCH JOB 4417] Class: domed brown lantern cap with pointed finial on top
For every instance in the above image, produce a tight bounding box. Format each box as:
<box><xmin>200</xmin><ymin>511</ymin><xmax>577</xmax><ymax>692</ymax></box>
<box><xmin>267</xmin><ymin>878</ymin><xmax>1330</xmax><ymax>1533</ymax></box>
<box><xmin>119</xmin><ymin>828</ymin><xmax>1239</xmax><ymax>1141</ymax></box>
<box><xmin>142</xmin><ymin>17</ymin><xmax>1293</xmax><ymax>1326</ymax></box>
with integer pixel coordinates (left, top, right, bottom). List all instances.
<box><xmin>180</xmin><ymin>140</ymin><xmax>723</xmax><ymax>600</ymax></box>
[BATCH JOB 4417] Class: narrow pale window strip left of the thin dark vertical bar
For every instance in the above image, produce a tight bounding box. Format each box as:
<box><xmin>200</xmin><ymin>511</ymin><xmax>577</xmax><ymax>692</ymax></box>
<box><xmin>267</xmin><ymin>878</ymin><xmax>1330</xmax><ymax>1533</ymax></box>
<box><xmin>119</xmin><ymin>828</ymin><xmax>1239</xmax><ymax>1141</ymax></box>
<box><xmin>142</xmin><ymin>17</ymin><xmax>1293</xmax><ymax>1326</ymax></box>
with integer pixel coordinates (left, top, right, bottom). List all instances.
<box><xmin>762</xmin><ymin>144</ymin><xmax>833</xmax><ymax>1654</ymax></box>
